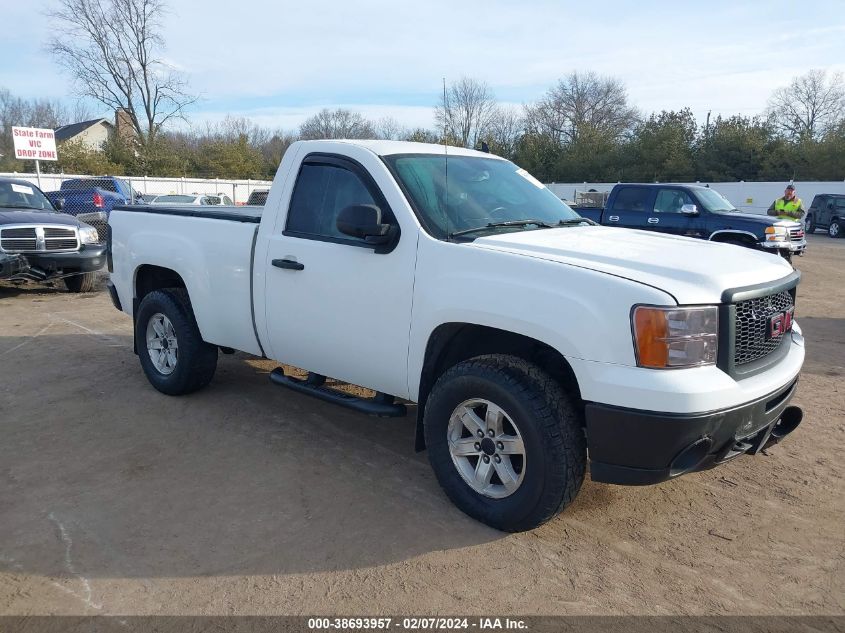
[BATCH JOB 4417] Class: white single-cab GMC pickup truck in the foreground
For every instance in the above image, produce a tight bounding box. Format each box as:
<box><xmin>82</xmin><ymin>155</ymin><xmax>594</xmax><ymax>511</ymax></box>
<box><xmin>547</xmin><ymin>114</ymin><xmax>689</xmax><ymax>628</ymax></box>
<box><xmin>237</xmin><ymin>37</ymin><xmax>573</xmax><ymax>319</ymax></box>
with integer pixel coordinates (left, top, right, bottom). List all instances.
<box><xmin>109</xmin><ymin>141</ymin><xmax>804</xmax><ymax>531</ymax></box>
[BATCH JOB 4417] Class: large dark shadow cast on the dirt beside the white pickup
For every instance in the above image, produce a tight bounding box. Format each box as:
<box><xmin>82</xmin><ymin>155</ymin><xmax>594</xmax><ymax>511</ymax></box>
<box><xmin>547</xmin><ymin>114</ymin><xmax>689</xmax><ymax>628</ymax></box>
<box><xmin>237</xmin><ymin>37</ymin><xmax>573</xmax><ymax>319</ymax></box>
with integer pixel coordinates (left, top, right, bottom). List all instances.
<box><xmin>0</xmin><ymin>334</ymin><xmax>608</xmax><ymax>577</ymax></box>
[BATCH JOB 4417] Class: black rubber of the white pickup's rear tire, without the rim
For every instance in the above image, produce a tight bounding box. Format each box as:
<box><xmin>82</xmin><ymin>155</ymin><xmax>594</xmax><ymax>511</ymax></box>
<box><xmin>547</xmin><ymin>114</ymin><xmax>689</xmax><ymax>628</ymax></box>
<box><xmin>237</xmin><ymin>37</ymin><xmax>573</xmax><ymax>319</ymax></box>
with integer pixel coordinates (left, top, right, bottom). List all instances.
<box><xmin>135</xmin><ymin>288</ymin><xmax>217</xmax><ymax>396</ymax></box>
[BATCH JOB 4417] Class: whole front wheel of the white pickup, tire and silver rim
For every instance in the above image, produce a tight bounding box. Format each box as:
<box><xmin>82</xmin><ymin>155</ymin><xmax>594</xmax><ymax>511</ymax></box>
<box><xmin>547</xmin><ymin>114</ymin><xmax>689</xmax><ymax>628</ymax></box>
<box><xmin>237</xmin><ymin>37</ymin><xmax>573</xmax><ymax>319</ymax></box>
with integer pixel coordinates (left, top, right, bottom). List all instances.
<box><xmin>423</xmin><ymin>355</ymin><xmax>587</xmax><ymax>532</ymax></box>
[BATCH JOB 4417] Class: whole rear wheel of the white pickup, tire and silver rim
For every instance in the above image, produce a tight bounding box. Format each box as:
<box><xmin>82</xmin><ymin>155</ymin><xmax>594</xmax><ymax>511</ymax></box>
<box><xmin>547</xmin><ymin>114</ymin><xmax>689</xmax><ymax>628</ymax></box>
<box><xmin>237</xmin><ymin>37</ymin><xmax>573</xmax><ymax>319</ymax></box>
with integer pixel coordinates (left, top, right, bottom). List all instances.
<box><xmin>135</xmin><ymin>288</ymin><xmax>217</xmax><ymax>396</ymax></box>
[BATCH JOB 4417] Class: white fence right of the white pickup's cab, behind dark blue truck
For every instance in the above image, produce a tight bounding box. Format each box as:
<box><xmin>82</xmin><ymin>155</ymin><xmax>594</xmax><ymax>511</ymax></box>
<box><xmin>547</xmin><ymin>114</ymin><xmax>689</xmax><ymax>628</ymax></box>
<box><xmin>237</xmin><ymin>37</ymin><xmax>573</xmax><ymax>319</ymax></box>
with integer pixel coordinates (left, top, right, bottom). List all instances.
<box><xmin>547</xmin><ymin>180</ymin><xmax>845</xmax><ymax>214</ymax></box>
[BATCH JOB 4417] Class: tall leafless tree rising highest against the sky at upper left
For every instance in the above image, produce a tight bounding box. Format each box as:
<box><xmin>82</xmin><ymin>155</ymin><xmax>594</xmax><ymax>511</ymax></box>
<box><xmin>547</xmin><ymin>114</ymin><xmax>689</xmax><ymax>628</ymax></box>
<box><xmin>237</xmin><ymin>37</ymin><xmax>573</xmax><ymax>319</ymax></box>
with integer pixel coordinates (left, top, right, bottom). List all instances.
<box><xmin>49</xmin><ymin>0</ymin><xmax>196</xmax><ymax>145</ymax></box>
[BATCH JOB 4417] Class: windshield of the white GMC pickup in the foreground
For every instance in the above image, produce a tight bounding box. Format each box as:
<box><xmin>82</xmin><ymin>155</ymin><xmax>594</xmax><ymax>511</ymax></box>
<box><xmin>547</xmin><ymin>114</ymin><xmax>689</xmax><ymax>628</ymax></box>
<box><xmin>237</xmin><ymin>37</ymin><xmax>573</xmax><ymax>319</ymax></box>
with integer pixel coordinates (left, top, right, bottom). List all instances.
<box><xmin>384</xmin><ymin>154</ymin><xmax>580</xmax><ymax>239</ymax></box>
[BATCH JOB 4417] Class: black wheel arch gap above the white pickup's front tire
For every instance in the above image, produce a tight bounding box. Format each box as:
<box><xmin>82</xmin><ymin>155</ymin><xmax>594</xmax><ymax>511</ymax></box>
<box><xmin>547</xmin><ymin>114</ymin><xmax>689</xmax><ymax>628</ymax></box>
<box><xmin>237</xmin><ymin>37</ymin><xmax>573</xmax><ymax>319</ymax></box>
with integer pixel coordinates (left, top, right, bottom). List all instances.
<box><xmin>415</xmin><ymin>322</ymin><xmax>581</xmax><ymax>451</ymax></box>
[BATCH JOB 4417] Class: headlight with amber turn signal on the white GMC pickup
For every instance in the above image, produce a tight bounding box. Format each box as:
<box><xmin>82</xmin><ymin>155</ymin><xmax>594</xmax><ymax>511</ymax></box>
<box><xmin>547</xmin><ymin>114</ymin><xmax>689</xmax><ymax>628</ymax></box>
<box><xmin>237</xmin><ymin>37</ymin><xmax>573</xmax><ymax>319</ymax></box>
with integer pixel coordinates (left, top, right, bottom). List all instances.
<box><xmin>631</xmin><ymin>306</ymin><xmax>719</xmax><ymax>369</ymax></box>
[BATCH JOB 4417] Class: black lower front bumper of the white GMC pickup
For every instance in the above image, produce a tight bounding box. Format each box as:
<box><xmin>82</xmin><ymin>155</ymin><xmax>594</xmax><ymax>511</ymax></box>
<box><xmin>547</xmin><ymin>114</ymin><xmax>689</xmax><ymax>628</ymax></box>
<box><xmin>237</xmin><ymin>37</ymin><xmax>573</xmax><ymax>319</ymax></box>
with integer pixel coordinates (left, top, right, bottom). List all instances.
<box><xmin>586</xmin><ymin>378</ymin><xmax>802</xmax><ymax>485</ymax></box>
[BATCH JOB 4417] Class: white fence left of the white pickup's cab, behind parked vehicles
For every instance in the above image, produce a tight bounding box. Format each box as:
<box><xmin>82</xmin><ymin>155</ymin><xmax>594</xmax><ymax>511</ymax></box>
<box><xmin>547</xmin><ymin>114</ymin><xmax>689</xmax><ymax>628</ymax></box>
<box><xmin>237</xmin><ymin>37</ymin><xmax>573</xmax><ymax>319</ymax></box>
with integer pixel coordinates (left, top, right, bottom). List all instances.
<box><xmin>0</xmin><ymin>173</ymin><xmax>272</xmax><ymax>204</ymax></box>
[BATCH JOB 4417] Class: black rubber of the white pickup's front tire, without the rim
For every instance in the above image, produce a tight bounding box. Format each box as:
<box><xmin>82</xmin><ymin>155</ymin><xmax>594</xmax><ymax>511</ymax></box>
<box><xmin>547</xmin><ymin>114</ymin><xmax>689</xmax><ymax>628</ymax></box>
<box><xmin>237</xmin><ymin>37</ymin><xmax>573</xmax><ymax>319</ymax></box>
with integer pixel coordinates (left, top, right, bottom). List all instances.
<box><xmin>423</xmin><ymin>355</ymin><xmax>587</xmax><ymax>532</ymax></box>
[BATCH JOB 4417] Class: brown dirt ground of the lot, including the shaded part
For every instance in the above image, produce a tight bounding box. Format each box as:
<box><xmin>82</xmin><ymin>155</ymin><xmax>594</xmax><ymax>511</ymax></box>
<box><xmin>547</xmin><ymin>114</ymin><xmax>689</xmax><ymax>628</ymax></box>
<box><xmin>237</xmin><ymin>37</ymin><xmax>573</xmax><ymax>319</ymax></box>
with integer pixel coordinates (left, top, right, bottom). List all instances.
<box><xmin>0</xmin><ymin>235</ymin><xmax>845</xmax><ymax>615</ymax></box>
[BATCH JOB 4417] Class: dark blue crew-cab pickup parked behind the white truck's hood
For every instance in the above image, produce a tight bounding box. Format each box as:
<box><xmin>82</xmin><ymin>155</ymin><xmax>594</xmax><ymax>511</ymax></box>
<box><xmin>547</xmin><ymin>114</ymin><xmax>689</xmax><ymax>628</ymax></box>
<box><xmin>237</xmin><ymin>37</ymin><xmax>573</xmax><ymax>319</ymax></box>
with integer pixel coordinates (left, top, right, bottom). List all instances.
<box><xmin>574</xmin><ymin>184</ymin><xmax>807</xmax><ymax>259</ymax></box>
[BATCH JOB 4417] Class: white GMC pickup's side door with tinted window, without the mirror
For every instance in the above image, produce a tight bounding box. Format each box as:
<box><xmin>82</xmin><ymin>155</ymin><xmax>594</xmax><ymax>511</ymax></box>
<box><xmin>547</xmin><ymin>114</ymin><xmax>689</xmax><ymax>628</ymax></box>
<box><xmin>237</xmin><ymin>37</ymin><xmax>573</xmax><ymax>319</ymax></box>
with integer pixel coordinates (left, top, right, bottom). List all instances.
<box><xmin>258</xmin><ymin>154</ymin><xmax>416</xmax><ymax>397</ymax></box>
